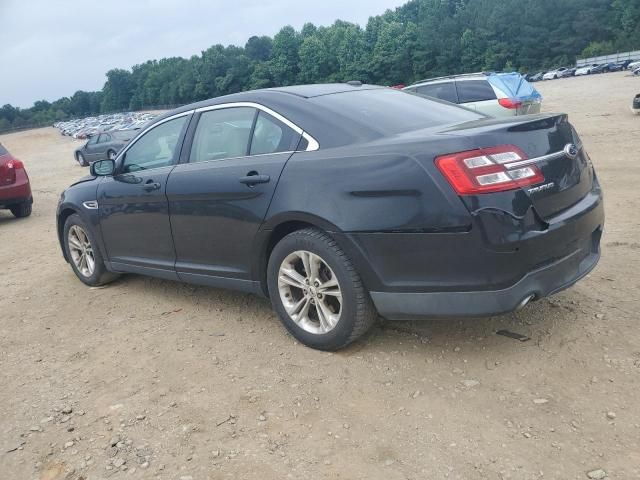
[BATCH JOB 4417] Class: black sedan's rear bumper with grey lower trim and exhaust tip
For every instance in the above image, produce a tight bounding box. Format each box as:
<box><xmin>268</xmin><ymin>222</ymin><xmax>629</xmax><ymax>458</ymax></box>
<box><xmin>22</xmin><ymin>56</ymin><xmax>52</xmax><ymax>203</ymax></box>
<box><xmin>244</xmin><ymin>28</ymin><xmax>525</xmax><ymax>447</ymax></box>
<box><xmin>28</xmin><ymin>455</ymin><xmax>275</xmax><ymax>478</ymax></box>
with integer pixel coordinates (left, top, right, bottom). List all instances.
<box><xmin>351</xmin><ymin>187</ymin><xmax>604</xmax><ymax>320</ymax></box>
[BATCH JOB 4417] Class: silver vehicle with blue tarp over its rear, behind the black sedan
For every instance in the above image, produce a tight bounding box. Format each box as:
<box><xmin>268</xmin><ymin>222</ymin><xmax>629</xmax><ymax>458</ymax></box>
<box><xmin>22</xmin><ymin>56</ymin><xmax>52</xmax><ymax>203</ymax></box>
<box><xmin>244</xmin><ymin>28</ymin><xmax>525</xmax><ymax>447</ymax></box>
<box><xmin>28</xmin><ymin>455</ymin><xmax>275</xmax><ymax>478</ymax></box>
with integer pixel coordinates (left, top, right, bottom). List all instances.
<box><xmin>404</xmin><ymin>73</ymin><xmax>542</xmax><ymax>117</ymax></box>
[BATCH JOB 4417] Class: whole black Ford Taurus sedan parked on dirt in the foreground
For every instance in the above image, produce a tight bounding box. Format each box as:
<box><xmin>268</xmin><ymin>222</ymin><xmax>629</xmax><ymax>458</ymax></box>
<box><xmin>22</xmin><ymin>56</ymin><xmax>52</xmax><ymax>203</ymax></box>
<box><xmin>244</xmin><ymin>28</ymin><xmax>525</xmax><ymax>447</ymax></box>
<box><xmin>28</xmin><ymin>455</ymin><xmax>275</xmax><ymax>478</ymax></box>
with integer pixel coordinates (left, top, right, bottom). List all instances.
<box><xmin>57</xmin><ymin>82</ymin><xmax>604</xmax><ymax>350</ymax></box>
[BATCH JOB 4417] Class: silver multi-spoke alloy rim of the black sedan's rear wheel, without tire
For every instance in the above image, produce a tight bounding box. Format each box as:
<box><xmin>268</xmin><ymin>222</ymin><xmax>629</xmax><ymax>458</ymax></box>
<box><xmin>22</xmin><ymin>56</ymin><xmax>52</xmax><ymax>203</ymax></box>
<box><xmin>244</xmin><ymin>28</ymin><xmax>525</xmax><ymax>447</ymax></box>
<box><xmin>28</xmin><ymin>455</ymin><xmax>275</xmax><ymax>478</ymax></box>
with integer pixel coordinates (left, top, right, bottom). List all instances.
<box><xmin>278</xmin><ymin>250</ymin><xmax>342</xmax><ymax>334</ymax></box>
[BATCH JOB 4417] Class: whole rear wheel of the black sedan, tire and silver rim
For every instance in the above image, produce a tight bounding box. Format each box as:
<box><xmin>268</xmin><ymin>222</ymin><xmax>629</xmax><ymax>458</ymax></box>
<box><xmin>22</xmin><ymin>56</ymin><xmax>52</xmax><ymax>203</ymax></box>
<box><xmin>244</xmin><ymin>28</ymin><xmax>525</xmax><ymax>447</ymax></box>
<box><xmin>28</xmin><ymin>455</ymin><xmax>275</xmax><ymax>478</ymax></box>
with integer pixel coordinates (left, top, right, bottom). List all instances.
<box><xmin>267</xmin><ymin>228</ymin><xmax>377</xmax><ymax>351</ymax></box>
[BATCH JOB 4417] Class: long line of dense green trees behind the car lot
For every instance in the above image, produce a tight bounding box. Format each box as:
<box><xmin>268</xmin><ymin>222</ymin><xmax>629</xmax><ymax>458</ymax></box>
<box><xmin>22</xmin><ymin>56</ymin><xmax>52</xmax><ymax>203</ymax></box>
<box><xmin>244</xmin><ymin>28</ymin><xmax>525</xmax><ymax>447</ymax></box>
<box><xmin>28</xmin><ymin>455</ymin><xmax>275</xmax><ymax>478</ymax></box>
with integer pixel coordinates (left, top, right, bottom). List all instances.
<box><xmin>0</xmin><ymin>0</ymin><xmax>640</xmax><ymax>131</ymax></box>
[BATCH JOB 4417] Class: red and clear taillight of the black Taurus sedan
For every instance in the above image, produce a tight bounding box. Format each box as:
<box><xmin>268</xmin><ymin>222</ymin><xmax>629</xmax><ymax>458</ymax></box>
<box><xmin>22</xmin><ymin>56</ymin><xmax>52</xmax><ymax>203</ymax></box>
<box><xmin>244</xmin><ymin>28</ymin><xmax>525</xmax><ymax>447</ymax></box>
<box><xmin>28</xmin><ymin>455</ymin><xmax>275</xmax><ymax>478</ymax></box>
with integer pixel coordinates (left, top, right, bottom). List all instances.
<box><xmin>435</xmin><ymin>145</ymin><xmax>544</xmax><ymax>195</ymax></box>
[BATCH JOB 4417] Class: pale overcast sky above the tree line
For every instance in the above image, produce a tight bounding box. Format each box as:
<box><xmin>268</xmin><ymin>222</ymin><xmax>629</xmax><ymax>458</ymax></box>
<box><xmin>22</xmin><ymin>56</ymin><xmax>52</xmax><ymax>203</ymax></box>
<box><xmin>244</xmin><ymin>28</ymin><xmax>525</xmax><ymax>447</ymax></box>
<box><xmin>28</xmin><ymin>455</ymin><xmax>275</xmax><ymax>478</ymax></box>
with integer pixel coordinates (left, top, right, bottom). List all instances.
<box><xmin>0</xmin><ymin>0</ymin><xmax>406</xmax><ymax>108</ymax></box>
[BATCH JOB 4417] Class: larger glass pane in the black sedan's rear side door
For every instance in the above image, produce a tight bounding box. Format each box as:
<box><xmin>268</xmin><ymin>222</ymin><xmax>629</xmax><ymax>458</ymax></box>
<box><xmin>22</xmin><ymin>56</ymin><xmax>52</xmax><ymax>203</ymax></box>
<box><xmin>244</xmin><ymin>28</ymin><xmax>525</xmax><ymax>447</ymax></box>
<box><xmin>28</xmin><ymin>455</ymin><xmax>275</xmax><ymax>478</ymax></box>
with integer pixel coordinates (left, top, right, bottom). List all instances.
<box><xmin>189</xmin><ymin>107</ymin><xmax>256</xmax><ymax>163</ymax></box>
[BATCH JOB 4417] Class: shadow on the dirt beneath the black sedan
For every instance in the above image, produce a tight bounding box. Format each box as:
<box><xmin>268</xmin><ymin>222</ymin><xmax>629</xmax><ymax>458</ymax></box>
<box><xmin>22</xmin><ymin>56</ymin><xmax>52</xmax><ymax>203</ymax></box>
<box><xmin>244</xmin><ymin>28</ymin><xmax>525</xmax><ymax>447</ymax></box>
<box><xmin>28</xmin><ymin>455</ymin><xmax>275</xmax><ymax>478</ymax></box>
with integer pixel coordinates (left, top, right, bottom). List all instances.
<box><xmin>104</xmin><ymin>275</ymin><xmax>580</xmax><ymax>355</ymax></box>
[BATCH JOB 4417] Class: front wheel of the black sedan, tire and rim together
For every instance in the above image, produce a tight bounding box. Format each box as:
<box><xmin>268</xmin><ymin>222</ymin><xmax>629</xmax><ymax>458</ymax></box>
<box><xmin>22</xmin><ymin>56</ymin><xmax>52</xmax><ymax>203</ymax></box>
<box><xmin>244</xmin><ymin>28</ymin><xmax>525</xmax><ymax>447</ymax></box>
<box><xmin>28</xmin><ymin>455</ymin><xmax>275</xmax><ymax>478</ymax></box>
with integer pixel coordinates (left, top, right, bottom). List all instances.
<box><xmin>64</xmin><ymin>214</ymin><xmax>118</xmax><ymax>287</ymax></box>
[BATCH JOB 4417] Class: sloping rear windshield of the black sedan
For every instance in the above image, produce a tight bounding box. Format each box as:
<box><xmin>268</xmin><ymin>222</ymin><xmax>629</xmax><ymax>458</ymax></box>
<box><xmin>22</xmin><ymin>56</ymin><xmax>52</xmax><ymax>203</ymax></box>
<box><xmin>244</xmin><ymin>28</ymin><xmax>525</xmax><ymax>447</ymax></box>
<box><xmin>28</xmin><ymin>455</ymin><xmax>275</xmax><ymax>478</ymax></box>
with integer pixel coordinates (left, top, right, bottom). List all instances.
<box><xmin>309</xmin><ymin>88</ymin><xmax>483</xmax><ymax>135</ymax></box>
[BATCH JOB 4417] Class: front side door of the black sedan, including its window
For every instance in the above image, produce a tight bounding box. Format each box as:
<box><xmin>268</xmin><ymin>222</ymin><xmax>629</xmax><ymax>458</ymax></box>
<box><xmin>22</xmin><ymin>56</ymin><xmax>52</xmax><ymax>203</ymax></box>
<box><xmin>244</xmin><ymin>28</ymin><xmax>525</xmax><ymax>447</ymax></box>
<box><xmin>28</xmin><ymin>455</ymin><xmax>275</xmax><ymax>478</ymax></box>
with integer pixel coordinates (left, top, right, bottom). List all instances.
<box><xmin>98</xmin><ymin>112</ymin><xmax>190</xmax><ymax>279</ymax></box>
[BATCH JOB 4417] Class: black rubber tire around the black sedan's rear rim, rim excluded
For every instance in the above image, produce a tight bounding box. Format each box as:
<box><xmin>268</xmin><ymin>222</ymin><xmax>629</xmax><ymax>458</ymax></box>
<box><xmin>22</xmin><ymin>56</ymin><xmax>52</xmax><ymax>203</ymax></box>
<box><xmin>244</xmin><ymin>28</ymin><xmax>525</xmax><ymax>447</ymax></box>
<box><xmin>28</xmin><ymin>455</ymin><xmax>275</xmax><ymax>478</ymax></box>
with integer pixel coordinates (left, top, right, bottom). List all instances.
<box><xmin>267</xmin><ymin>228</ymin><xmax>378</xmax><ymax>351</ymax></box>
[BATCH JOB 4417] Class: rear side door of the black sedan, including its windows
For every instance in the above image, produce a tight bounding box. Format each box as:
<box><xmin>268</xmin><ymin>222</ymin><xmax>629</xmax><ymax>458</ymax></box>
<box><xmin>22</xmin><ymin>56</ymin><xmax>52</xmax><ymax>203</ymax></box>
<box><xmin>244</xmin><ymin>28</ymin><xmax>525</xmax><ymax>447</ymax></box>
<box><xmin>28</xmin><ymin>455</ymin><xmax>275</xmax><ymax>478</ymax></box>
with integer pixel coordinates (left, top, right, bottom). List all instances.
<box><xmin>167</xmin><ymin>106</ymin><xmax>302</xmax><ymax>291</ymax></box>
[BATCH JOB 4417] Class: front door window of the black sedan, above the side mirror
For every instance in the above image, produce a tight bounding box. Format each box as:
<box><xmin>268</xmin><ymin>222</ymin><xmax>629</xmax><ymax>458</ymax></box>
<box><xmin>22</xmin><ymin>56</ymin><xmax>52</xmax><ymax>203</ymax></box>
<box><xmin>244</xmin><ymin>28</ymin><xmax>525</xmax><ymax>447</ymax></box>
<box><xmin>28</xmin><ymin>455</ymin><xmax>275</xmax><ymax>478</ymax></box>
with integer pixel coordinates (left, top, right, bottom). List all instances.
<box><xmin>122</xmin><ymin>115</ymin><xmax>189</xmax><ymax>173</ymax></box>
